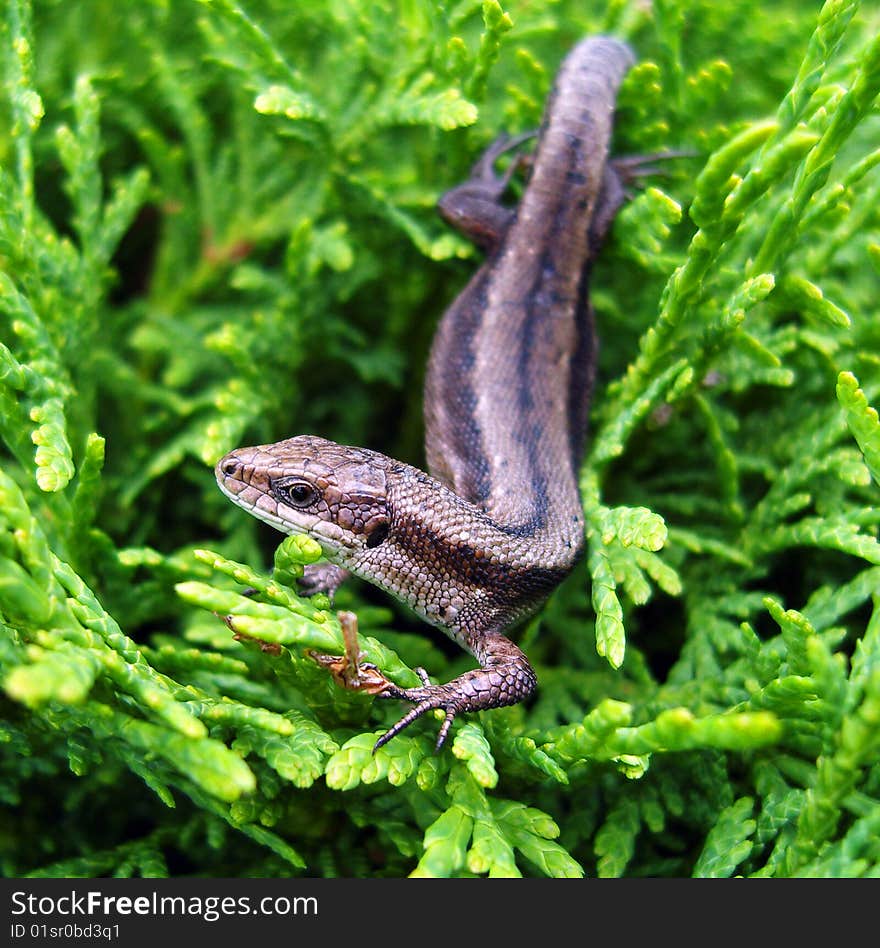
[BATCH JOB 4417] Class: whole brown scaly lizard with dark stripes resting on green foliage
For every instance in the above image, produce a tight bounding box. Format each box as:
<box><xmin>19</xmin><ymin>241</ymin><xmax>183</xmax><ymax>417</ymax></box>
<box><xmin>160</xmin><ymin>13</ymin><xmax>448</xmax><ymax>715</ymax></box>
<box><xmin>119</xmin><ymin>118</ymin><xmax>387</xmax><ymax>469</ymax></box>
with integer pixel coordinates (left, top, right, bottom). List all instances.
<box><xmin>215</xmin><ymin>36</ymin><xmax>634</xmax><ymax>750</ymax></box>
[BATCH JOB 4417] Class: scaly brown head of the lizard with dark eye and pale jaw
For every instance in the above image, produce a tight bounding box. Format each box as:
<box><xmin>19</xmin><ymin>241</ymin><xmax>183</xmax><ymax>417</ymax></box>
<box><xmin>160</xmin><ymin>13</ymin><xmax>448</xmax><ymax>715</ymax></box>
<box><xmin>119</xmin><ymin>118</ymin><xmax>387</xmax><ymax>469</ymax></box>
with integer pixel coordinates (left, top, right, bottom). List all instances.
<box><xmin>214</xmin><ymin>435</ymin><xmax>394</xmax><ymax>565</ymax></box>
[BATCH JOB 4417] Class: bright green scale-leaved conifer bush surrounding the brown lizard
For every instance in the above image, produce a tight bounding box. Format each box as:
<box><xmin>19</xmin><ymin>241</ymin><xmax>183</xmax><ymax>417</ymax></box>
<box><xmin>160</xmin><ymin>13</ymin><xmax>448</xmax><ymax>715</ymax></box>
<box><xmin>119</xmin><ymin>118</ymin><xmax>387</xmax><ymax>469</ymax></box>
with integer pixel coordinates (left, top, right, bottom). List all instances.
<box><xmin>0</xmin><ymin>0</ymin><xmax>880</xmax><ymax>876</ymax></box>
